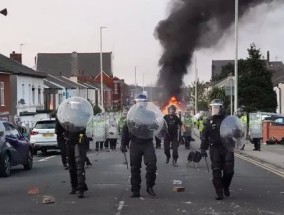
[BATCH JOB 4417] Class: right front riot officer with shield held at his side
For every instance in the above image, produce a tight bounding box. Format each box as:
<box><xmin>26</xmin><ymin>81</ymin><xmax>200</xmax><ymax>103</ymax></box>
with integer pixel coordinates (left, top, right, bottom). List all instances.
<box><xmin>201</xmin><ymin>99</ymin><xmax>234</xmax><ymax>200</ymax></box>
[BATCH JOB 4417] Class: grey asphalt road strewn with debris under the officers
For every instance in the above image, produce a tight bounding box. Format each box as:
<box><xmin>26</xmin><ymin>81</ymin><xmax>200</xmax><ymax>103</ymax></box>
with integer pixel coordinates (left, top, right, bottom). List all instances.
<box><xmin>0</xmin><ymin>141</ymin><xmax>284</xmax><ymax>215</ymax></box>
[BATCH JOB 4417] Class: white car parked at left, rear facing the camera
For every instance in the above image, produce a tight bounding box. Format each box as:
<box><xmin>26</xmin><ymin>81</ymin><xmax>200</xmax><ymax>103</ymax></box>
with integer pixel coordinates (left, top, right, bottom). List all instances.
<box><xmin>30</xmin><ymin>118</ymin><xmax>59</xmax><ymax>155</ymax></box>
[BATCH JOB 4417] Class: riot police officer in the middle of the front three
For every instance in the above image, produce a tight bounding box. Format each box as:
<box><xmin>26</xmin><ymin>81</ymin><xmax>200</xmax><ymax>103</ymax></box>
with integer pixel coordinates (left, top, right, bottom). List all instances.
<box><xmin>120</xmin><ymin>94</ymin><xmax>157</xmax><ymax>198</ymax></box>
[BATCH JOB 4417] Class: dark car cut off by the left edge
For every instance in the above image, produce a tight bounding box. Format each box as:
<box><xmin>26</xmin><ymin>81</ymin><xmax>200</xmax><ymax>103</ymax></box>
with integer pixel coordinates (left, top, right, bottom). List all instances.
<box><xmin>0</xmin><ymin>121</ymin><xmax>33</xmax><ymax>177</ymax></box>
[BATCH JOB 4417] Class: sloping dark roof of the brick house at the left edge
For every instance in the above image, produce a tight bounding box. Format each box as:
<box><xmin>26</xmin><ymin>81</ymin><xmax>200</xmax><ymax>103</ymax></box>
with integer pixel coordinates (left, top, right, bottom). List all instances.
<box><xmin>0</xmin><ymin>54</ymin><xmax>46</xmax><ymax>78</ymax></box>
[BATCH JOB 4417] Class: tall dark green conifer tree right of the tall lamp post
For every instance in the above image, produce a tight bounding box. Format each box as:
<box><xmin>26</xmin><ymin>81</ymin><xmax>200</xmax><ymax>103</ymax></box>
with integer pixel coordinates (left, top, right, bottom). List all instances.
<box><xmin>238</xmin><ymin>44</ymin><xmax>277</xmax><ymax>112</ymax></box>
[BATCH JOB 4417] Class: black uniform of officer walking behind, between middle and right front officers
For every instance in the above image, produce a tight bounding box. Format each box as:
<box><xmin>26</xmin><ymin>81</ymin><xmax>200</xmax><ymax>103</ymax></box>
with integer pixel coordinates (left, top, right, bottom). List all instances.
<box><xmin>164</xmin><ymin>114</ymin><xmax>182</xmax><ymax>162</ymax></box>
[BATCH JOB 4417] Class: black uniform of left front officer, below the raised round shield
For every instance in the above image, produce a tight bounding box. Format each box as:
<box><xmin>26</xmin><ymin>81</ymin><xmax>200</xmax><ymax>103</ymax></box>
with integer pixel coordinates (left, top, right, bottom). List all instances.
<box><xmin>65</xmin><ymin>130</ymin><xmax>88</xmax><ymax>198</ymax></box>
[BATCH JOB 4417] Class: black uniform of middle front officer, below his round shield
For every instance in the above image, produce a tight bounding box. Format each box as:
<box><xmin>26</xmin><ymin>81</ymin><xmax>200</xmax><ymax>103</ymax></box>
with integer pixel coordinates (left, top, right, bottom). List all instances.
<box><xmin>121</xmin><ymin>123</ymin><xmax>157</xmax><ymax>197</ymax></box>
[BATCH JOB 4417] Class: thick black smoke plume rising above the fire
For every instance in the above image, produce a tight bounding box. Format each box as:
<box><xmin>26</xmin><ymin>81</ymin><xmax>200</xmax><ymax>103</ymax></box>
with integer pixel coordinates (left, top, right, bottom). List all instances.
<box><xmin>155</xmin><ymin>0</ymin><xmax>278</xmax><ymax>101</ymax></box>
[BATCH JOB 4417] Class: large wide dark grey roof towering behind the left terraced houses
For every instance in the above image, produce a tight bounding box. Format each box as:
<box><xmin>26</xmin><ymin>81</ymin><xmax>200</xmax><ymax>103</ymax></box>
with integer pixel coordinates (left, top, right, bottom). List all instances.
<box><xmin>36</xmin><ymin>52</ymin><xmax>112</xmax><ymax>77</ymax></box>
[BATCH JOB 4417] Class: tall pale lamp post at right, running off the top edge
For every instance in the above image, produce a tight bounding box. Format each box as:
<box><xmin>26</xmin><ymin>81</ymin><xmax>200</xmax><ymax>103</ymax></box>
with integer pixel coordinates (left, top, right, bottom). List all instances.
<box><xmin>234</xmin><ymin>0</ymin><xmax>239</xmax><ymax>114</ymax></box>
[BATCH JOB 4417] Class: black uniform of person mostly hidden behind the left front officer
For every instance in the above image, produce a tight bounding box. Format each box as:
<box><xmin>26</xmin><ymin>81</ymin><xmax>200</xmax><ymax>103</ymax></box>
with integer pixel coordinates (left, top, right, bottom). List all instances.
<box><xmin>55</xmin><ymin>117</ymin><xmax>67</xmax><ymax>168</ymax></box>
